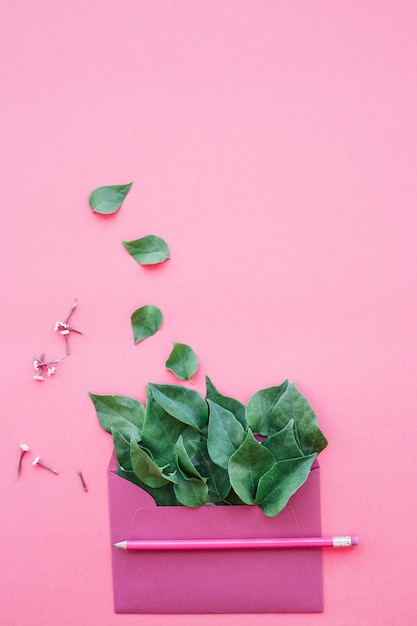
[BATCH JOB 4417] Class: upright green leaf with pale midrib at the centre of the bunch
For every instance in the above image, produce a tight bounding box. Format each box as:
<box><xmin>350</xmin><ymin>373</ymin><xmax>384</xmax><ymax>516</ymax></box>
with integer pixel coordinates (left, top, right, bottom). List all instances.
<box><xmin>207</xmin><ymin>400</ymin><xmax>245</xmax><ymax>470</ymax></box>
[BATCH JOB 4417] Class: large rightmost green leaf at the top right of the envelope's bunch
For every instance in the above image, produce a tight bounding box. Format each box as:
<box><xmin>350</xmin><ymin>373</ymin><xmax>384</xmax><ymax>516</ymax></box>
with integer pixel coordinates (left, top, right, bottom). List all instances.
<box><xmin>272</xmin><ymin>383</ymin><xmax>327</xmax><ymax>455</ymax></box>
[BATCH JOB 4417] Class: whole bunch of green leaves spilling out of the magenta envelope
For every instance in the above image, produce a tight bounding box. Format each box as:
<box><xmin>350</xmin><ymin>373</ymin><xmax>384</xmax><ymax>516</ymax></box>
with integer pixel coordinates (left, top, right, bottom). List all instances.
<box><xmin>90</xmin><ymin>378</ymin><xmax>327</xmax><ymax>517</ymax></box>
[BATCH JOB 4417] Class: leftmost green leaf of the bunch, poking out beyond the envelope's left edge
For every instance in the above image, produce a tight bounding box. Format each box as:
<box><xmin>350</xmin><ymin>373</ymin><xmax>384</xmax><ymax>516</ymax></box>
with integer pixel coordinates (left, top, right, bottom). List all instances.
<box><xmin>89</xmin><ymin>393</ymin><xmax>145</xmax><ymax>441</ymax></box>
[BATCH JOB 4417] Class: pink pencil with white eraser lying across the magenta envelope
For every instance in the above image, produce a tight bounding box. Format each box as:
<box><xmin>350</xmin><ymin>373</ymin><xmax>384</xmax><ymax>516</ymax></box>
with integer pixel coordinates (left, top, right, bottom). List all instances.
<box><xmin>113</xmin><ymin>536</ymin><xmax>359</xmax><ymax>550</ymax></box>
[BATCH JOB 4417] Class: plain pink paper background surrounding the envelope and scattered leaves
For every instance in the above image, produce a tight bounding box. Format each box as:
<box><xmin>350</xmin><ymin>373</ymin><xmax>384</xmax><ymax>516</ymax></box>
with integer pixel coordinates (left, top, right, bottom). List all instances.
<box><xmin>0</xmin><ymin>0</ymin><xmax>417</xmax><ymax>626</ymax></box>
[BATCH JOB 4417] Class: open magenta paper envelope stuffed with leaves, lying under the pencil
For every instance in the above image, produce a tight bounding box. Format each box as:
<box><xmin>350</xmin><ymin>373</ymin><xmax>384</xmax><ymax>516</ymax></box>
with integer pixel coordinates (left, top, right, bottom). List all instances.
<box><xmin>108</xmin><ymin>455</ymin><xmax>323</xmax><ymax>613</ymax></box>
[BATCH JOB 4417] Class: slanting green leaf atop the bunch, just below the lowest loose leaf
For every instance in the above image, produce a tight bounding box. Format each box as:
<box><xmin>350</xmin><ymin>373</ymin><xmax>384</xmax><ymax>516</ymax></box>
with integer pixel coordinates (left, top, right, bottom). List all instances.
<box><xmin>149</xmin><ymin>383</ymin><xmax>208</xmax><ymax>430</ymax></box>
